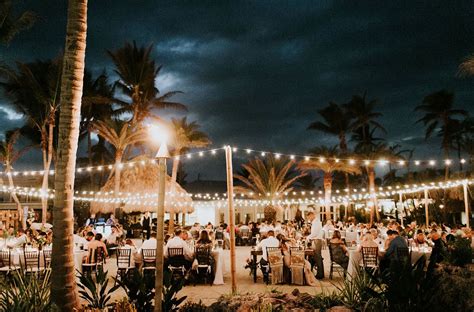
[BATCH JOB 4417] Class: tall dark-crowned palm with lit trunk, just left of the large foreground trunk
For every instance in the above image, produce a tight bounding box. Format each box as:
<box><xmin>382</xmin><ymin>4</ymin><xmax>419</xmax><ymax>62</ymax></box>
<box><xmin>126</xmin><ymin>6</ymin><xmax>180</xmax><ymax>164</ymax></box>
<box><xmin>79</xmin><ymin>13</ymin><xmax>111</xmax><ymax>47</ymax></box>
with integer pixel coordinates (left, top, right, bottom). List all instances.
<box><xmin>0</xmin><ymin>58</ymin><xmax>61</xmax><ymax>223</ymax></box>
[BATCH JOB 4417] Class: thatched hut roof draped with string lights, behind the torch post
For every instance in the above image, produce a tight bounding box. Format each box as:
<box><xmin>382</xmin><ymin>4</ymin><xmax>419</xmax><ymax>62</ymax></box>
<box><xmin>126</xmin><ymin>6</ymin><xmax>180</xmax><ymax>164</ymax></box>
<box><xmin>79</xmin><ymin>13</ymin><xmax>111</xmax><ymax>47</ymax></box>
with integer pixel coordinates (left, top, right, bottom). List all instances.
<box><xmin>91</xmin><ymin>156</ymin><xmax>194</xmax><ymax>213</ymax></box>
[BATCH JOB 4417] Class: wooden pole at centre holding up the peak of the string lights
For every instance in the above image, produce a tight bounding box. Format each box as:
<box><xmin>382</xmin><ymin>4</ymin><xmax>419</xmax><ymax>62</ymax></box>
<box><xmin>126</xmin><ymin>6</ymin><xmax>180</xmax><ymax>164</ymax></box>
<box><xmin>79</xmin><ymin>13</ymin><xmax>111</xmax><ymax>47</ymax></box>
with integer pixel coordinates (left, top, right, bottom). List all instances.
<box><xmin>225</xmin><ymin>146</ymin><xmax>237</xmax><ymax>294</ymax></box>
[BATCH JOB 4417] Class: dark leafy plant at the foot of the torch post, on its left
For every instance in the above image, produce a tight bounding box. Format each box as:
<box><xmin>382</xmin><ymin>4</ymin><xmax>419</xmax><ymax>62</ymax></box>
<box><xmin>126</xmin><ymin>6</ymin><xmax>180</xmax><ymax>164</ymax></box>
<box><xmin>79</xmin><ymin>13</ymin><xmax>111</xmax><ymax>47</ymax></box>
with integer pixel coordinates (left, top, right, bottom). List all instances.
<box><xmin>117</xmin><ymin>269</ymin><xmax>155</xmax><ymax>312</ymax></box>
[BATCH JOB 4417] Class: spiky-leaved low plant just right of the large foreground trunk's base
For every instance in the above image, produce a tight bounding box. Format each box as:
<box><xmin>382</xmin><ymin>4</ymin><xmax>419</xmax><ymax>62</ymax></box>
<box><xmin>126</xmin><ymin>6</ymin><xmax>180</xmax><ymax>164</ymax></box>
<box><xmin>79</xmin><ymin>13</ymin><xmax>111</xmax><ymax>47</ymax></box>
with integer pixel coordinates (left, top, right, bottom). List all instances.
<box><xmin>77</xmin><ymin>267</ymin><xmax>119</xmax><ymax>309</ymax></box>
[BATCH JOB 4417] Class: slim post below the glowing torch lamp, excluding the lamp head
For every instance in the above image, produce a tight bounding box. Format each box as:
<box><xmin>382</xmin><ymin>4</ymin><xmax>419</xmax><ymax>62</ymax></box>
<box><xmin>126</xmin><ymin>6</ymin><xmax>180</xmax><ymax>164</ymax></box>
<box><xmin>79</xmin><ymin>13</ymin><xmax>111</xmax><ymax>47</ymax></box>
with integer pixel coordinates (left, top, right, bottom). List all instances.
<box><xmin>155</xmin><ymin>157</ymin><xmax>166</xmax><ymax>312</ymax></box>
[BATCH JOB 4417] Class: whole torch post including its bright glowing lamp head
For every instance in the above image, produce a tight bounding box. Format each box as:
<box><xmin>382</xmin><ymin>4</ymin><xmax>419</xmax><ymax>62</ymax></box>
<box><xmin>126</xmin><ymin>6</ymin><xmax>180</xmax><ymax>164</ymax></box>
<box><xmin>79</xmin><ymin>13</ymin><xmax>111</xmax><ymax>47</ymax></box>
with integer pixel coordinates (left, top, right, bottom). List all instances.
<box><xmin>150</xmin><ymin>127</ymin><xmax>169</xmax><ymax>312</ymax></box>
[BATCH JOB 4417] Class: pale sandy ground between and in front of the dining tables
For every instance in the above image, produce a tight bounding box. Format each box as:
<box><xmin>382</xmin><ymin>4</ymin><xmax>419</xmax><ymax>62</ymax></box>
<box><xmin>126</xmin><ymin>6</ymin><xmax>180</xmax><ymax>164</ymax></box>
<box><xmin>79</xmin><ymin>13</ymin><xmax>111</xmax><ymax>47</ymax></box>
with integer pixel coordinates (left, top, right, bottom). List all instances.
<box><xmin>105</xmin><ymin>241</ymin><xmax>342</xmax><ymax>304</ymax></box>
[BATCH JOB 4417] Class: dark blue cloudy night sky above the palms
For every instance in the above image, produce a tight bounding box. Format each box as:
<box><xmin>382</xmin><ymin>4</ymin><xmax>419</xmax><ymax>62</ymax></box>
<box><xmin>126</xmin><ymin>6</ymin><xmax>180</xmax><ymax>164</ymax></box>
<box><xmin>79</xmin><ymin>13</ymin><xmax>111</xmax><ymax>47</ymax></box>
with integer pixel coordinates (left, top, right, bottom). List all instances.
<box><xmin>0</xmin><ymin>0</ymin><xmax>474</xmax><ymax>178</ymax></box>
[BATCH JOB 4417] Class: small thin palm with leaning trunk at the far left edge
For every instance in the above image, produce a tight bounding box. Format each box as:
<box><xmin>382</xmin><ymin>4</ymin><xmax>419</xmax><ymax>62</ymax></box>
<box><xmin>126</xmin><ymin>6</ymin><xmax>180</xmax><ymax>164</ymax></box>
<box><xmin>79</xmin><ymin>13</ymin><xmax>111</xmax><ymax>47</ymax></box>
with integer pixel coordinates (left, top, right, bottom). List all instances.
<box><xmin>0</xmin><ymin>129</ymin><xmax>29</xmax><ymax>225</ymax></box>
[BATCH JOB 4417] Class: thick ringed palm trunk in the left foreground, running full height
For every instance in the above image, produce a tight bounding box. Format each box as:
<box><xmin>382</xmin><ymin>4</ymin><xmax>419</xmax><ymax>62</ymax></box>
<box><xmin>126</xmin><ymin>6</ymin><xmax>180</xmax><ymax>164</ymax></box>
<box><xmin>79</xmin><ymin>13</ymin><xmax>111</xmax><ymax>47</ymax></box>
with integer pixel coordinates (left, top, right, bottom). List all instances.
<box><xmin>51</xmin><ymin>0</ymin><xmax>87</xmax><ymax>311</ymax></box>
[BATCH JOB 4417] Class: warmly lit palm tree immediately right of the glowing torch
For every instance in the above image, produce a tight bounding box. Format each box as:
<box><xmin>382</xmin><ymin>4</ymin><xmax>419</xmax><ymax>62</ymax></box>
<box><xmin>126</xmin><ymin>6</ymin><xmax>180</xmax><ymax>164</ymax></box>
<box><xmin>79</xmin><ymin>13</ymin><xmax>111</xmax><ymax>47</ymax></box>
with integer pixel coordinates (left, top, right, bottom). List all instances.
<box><xmin>168</xmin><ymin>117</ymin><xmax>211</xmax><ymax>233</ymax></box>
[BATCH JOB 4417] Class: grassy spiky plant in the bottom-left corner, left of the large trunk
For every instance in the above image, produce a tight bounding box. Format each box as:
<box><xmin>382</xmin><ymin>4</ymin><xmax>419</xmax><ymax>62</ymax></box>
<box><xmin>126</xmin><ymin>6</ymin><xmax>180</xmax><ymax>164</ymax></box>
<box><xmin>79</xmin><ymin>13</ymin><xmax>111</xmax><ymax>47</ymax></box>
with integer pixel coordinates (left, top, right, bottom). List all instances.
<box><xmin>0</xmin><ymin>271</ymin><xmax>51</xmax><ymax>312</ymax></box>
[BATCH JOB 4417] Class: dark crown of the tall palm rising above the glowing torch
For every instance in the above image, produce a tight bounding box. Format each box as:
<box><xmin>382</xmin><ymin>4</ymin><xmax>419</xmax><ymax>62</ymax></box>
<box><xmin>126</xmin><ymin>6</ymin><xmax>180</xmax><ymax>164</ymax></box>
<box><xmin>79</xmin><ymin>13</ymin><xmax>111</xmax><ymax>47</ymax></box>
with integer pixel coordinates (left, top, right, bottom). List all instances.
<box><xmin>107</xmin><ymin>41</ymin><xmax>187</xmax><ymax>126</ymax></box>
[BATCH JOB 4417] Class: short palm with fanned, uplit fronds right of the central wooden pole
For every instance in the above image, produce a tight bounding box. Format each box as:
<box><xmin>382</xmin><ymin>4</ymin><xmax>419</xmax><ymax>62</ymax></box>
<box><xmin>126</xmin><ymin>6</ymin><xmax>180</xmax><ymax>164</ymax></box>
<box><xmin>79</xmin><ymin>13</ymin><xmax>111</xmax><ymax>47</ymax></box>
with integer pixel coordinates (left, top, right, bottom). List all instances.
<box><xmin>234</xmin><ymin>156</ymin><xmax>306</xmax><ymax>221</ymax></box>
